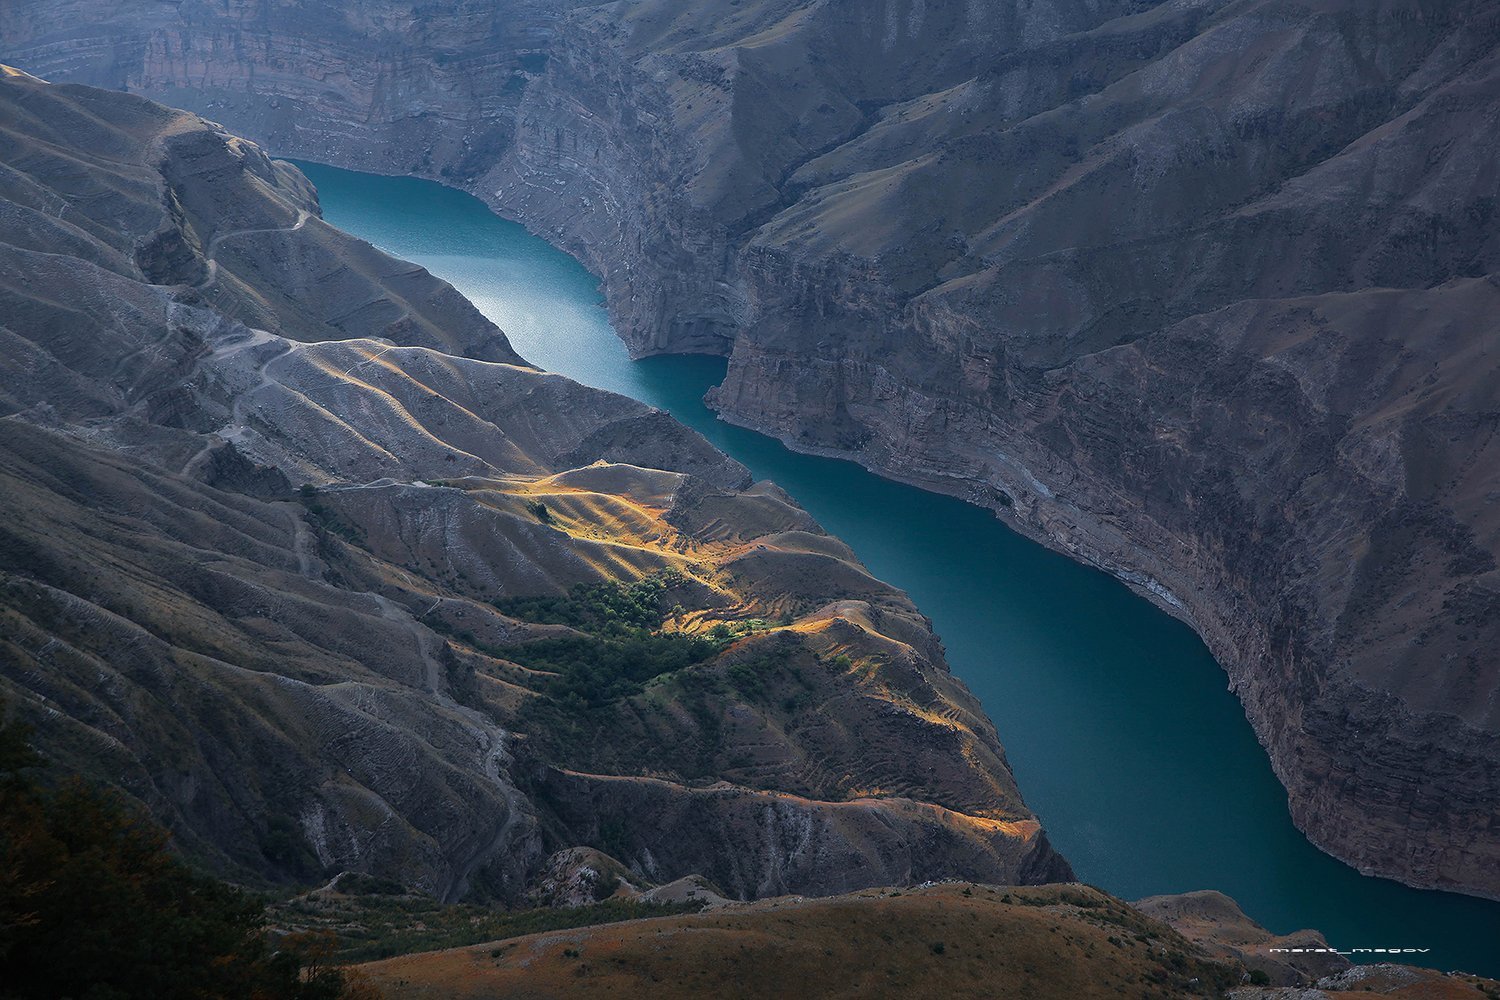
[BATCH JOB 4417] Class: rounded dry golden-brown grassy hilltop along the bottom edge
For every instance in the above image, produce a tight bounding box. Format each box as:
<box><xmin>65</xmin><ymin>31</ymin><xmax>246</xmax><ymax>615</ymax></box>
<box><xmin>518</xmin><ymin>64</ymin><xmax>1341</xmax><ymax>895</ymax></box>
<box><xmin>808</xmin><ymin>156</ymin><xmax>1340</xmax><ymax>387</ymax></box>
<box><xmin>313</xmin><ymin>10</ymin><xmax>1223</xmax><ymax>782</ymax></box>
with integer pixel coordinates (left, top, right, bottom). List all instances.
<box><xmin>362</xmin><ymin>885</ymin><xmax>1241</xmax><ymax>1000</ymax></box>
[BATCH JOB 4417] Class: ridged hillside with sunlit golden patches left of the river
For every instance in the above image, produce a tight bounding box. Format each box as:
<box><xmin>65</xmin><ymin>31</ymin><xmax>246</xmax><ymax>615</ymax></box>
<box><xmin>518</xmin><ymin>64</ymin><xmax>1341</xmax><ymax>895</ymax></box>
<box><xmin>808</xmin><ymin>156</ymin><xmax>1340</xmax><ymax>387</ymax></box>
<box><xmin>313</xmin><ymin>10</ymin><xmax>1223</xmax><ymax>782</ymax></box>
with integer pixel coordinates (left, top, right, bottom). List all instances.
<box><xmin>0</xmin><ymin>68</ymin><xmax>1070</xmax><ymax>901</ymax></box>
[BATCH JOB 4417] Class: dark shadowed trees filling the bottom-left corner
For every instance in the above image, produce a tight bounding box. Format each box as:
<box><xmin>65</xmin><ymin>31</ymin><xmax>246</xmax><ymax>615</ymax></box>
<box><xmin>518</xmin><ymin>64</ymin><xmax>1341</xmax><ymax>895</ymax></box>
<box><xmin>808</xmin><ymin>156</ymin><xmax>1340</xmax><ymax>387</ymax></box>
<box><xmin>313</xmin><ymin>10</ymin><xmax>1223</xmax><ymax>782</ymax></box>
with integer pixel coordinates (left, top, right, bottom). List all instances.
<box><xmin>0</xmin><ymin>703</ymin><xmax>378</xmax><ymax>1000</ymax></box>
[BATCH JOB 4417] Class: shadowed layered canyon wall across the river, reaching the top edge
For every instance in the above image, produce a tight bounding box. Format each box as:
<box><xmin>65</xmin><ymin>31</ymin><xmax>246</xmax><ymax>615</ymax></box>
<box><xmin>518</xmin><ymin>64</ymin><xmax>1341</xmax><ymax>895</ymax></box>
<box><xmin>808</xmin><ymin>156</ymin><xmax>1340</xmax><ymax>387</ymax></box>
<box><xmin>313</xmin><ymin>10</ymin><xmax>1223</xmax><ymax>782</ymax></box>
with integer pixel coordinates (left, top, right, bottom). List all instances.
<box><xmin>0</xmin><ymin>0</ymin><xmax>1500</xmax><ymax>897</ymax></box>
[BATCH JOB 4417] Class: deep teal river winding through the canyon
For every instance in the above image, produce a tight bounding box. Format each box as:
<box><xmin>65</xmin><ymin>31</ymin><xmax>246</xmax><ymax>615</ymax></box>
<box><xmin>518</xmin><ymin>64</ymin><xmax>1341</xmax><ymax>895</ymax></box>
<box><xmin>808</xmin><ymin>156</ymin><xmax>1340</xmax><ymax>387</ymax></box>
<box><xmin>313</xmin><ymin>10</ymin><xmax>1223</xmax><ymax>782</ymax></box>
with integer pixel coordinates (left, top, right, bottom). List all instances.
<box><xmin>300</xmin><ymin>163</ymin><xmax>1500</xmax><ymax>976</ymax></box>
